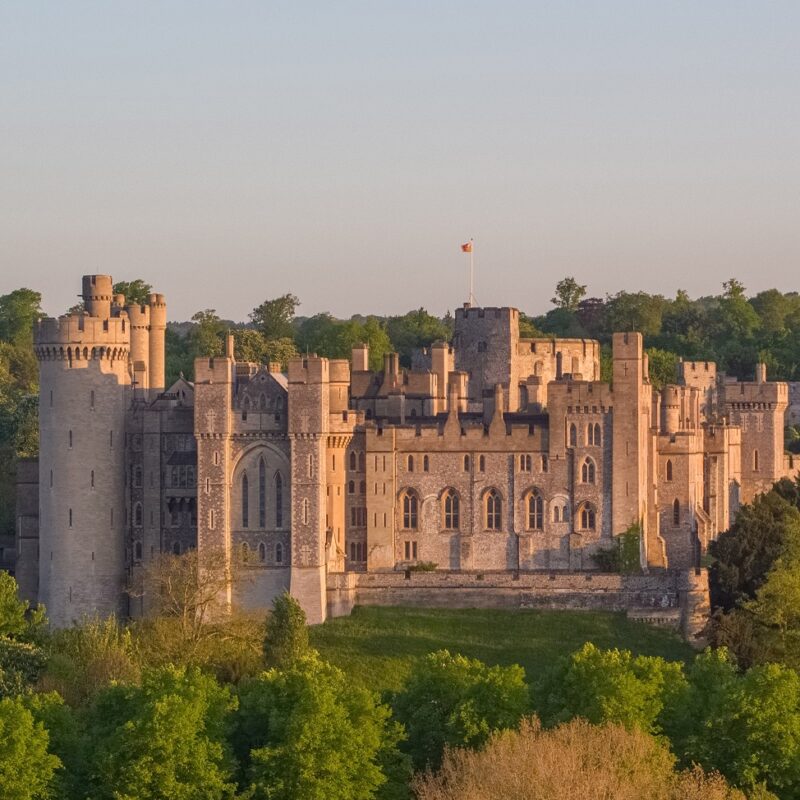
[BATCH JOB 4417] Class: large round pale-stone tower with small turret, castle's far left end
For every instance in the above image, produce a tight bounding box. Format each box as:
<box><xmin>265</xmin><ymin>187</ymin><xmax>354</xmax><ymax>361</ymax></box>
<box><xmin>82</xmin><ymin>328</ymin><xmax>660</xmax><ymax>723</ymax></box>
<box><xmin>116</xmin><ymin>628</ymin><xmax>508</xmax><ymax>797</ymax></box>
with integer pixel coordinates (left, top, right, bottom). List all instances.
<box><xmin>35</xmin><ymin>275</ymin><xmax>130</xmax><ymax>627</ymax></box>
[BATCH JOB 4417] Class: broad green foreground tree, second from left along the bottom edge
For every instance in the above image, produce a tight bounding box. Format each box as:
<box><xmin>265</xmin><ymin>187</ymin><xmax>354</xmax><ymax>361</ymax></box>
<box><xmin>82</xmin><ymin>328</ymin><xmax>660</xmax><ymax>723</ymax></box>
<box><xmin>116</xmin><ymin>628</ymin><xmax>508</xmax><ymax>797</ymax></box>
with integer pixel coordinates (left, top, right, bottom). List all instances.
<box><xmin>85</xmin><ymin>666</ymin><xmax>237</xmax><ymax>800</ymax></box>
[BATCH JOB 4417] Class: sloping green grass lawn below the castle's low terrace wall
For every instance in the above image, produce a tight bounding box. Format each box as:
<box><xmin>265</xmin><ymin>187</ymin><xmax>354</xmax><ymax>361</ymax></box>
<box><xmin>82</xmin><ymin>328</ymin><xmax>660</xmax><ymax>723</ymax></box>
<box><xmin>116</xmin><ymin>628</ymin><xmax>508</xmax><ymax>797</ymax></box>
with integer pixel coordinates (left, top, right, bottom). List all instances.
<box><xmin>311</xmin><ymin>607</ymin><xmax>693</xmax><ymax>692</ymax></box>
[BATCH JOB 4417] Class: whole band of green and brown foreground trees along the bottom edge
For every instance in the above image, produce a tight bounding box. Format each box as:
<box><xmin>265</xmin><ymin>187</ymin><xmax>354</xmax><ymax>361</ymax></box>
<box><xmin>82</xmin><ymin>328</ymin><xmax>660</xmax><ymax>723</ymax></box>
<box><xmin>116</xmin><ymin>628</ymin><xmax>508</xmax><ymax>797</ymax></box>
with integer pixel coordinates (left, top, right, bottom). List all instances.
<box><xmin>0</xmin><ymin>575</ymin><xmax>800</xmax><ymax>800</ymax></box>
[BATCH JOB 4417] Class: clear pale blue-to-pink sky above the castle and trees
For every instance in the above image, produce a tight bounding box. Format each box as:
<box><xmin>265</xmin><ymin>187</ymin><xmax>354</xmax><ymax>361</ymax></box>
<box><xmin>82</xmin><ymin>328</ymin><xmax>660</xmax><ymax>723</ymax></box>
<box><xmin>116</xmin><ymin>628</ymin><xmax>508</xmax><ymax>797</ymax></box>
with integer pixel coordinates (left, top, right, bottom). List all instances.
<box><xmin>0</xmin><ymin>0</ymin><xmax>800</xmax><ymax>319</ymax></box>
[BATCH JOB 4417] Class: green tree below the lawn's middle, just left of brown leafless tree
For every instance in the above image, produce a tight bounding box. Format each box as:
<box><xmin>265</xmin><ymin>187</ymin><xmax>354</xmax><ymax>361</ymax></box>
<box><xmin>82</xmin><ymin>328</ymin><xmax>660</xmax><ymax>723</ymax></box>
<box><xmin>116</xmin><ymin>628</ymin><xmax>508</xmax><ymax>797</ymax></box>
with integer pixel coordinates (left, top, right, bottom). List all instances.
<box><xmin>392</xmin><ymin>650</ymin><xmax>530</xmax><ymax>769</ymax></box>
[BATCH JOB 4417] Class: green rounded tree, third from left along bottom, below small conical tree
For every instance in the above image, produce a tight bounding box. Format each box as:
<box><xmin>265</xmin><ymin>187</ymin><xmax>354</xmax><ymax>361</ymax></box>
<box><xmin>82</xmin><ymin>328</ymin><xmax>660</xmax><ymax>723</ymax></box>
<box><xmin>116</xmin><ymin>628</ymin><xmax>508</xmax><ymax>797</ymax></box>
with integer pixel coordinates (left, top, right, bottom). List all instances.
<box><xmin>234</xmin><ymin>653</ymin><xmax>400</xmax><ymax>800</ymax></box>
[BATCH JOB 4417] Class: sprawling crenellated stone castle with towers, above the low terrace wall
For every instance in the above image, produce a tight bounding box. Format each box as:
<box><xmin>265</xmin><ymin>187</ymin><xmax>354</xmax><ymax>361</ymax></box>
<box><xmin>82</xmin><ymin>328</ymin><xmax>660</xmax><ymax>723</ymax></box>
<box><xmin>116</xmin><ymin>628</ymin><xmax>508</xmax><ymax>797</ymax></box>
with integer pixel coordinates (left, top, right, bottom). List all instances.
<box><xmin>16</xmin><ymin>275</ymin><xmax>796</xmax><ymax>626</ymax></box>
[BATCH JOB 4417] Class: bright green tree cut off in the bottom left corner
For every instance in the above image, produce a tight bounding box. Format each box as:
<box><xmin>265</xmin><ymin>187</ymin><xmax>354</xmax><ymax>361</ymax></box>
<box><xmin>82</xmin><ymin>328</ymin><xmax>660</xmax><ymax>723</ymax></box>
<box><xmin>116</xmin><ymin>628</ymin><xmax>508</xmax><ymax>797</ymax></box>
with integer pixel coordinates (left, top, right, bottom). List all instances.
<box><xmin>0</xmin><ymin>697</ymin><xmax>61</xmax><ymax>800</ymax></box>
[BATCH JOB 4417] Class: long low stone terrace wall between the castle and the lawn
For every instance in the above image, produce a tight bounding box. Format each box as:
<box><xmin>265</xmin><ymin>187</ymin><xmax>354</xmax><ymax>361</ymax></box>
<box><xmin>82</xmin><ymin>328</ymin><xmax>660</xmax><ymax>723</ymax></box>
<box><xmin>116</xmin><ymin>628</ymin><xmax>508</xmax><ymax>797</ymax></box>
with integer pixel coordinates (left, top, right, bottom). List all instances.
<box><xmin>328</xmin><ymin>570</ymin><xmax>709</xmax><ymax>646</ymax></box>
